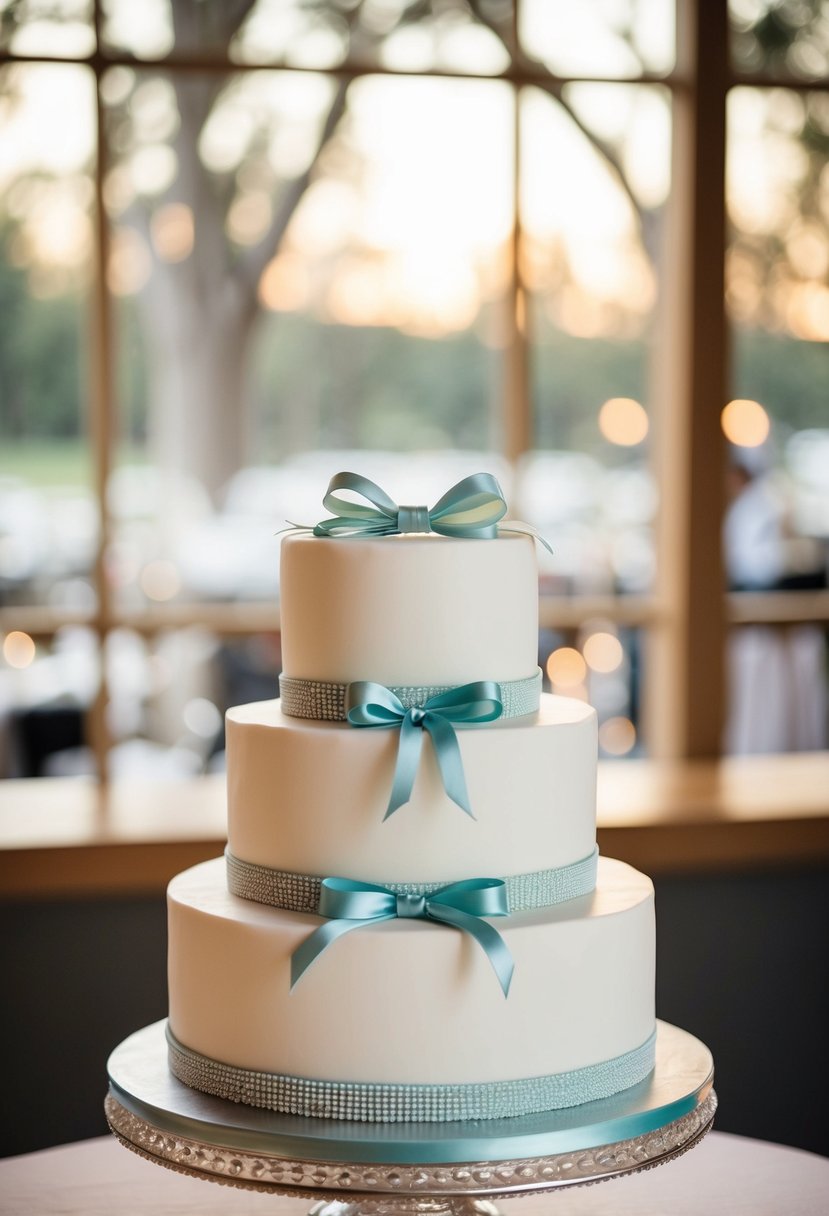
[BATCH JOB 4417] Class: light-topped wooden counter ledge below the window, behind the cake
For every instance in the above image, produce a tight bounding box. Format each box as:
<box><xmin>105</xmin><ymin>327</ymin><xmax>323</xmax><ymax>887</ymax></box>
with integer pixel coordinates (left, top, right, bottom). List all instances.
<box><xmin>0</xmin><ymin>753</ymin><xmax>829</xmax><ymax>899</ymax></box>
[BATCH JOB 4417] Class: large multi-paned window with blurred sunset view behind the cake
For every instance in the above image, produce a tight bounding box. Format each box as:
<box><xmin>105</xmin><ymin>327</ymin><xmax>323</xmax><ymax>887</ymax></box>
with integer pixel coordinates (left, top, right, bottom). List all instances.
<box><xmin>0</xmin><ymin>0</ymin><xmax>829</xmax><ymax>776</ymax></box>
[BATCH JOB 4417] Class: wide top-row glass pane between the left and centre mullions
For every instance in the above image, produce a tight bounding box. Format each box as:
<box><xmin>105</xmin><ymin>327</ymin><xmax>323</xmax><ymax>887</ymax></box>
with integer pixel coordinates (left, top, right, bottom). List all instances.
<box><xmin>103</xmin><ymin>0</ymin><xmax>512</xmax><ymax>74</ymax></box>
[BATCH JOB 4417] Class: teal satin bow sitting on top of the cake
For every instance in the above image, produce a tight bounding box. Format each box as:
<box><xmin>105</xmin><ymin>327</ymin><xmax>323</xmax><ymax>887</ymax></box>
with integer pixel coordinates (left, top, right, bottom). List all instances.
<box><xmin>314</xmin><ymin>473</ymin><xmax>507</xmax><ymax>537</ymax></box>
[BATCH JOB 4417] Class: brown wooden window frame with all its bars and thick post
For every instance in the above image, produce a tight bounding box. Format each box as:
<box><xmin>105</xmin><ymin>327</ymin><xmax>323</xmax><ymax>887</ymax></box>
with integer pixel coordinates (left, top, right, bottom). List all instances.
<box><xmin>0</xmin><ymin>0</ymin><xmax>829</xmax><ymax>781</ymax></box>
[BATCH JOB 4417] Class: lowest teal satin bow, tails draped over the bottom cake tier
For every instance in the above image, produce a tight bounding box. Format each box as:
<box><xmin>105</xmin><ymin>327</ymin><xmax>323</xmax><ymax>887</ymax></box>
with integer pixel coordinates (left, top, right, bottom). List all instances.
<box><xmin>291</xmin><ymin>878</ymin><xmax>514</xmax><ymax>996</ymax></box>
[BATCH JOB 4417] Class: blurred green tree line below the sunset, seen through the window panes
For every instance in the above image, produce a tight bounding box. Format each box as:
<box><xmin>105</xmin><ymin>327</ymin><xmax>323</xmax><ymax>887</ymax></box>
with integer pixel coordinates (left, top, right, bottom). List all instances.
<box><xmin>0</xmin><ymin>240</ymin><xmax>829</xmax><ymax>463</ymax></box>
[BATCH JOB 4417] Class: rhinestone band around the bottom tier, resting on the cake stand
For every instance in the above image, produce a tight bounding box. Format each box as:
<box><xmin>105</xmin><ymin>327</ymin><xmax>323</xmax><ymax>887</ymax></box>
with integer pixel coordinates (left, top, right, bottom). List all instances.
<box><xmin>167</xmin><ymin>1024</ymin><xmax>656</xmax><ymax>1124</ymax></box>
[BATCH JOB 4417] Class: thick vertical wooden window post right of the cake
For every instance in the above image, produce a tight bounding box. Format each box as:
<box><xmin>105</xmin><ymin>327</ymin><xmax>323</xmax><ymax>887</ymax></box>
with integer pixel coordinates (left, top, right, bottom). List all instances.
<box><xmin>645</xmin><ymin>0</ymin><xmax>728</xmax><ymax>758</ymax></box>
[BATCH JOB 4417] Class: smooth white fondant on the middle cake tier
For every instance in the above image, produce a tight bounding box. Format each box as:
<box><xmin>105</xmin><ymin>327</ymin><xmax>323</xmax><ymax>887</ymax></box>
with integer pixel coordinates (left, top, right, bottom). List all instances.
<box><xmin>227</xmin><ymin>695</ymin><xmax>596</xmax><ymax>883</ymax></box>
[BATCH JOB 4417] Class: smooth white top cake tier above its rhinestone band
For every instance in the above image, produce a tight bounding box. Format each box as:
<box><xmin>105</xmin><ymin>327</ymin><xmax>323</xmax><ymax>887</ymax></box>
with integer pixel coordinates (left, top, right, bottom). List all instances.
<box><xmin>280</xmin><ymin>535</ymin><xmax>538</xmax><ymax>687</ymax></box>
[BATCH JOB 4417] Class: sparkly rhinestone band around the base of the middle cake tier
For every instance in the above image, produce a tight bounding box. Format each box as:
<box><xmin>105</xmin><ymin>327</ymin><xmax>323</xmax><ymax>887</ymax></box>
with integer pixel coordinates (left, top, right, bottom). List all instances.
<box><xmin>225</xmin><ymin>849</ymin><xmax>599</xmax><ymax>912</ymax></box>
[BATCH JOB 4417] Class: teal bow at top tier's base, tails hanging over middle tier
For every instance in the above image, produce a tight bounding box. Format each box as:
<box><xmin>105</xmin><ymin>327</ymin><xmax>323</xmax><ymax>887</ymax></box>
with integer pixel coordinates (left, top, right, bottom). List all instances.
<box><xmin>345</xmin><ymin>680</ymin><xmax>503</xmax><ymax>820</ymax></box>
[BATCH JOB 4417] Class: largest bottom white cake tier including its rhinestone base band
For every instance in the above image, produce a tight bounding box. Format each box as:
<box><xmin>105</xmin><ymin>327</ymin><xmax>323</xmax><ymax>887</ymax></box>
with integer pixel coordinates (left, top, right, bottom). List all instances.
<box><xmin>168</xmin><ymin>858</ymin><xmax>655</xmax><ymax>1121</ymax></box>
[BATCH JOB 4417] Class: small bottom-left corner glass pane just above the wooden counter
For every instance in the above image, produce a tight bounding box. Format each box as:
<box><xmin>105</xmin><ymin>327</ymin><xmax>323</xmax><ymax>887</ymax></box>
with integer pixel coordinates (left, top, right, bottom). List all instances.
<box><xmin>0</xmin><ymin>626</ymin><xmax>100</xmax><ymax>777</ymax></box>
